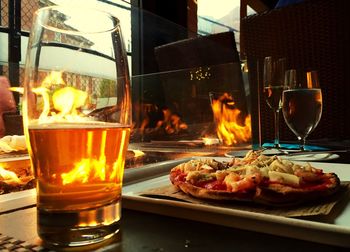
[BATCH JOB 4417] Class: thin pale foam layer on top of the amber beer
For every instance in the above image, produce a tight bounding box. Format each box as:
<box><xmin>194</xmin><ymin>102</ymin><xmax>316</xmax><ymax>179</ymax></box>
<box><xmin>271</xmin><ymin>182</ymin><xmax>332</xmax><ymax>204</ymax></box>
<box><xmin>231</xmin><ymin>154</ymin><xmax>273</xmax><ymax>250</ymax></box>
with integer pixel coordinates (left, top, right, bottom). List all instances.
<box><xmin>28</xmin><ymin>121</ymin><xmax>130</xmax><ymax>129</ymax></box>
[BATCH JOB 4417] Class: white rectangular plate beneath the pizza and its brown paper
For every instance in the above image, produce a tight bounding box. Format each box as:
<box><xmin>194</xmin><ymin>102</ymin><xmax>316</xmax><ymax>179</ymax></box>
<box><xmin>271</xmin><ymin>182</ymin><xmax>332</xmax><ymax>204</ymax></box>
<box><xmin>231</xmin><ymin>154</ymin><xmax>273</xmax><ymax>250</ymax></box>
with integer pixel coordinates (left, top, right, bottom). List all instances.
<box><xmin>123</xmin><ymin>158</ymin><xmax>350</xmax><ymax>247</ymax></box>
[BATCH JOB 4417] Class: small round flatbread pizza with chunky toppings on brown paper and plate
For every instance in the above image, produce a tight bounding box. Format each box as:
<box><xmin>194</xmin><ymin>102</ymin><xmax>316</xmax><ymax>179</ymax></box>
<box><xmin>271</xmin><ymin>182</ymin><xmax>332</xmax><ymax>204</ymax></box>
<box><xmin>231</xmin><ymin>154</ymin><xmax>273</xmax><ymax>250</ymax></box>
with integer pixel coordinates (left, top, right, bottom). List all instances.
<box><xmin>170</xmin><ymin>151</ymin><xmax>340</xmax><ymax>206</ymax></box>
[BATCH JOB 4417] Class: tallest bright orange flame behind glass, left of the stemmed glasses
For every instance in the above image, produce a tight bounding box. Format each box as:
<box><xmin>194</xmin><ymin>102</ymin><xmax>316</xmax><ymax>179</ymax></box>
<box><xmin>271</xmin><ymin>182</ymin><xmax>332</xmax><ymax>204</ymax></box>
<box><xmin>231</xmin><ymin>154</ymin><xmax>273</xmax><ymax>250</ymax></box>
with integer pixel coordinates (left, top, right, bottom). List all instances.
<box><xmin>211</xmin><ymin>93</ymin><xmax>251</xmax><ymax>146</ymax></box>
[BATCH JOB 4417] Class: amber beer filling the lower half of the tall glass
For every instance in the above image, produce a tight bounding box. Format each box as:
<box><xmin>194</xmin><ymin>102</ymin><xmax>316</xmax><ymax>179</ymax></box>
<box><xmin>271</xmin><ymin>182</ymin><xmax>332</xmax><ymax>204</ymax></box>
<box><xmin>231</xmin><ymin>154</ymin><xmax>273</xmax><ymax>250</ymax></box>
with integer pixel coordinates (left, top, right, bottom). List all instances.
<box><xmin>28</xmin><ymin>123</ymin><xmax>130</xmax><ymax>244</ymax></box>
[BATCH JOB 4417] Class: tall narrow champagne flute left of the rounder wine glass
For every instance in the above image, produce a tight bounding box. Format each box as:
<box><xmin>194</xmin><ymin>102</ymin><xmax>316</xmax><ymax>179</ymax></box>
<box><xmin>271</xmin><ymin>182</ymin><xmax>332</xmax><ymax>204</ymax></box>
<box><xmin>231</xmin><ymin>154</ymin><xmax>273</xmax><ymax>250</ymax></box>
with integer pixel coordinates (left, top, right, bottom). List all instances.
<box><xmin>263</xmin><ymin>56</ymin><xmax>286</xmax><ymax>149</ymax></box>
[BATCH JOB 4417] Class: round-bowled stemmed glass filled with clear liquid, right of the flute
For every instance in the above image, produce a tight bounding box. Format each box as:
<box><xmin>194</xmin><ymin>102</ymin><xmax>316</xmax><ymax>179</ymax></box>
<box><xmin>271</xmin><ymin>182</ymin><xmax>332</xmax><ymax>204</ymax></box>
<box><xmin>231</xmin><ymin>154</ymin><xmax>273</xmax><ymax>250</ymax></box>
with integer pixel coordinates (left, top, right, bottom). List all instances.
<box><xmin>282</xmin><ymin>69</ymin><xmax>322</xmax><ymax>151</ymax></box>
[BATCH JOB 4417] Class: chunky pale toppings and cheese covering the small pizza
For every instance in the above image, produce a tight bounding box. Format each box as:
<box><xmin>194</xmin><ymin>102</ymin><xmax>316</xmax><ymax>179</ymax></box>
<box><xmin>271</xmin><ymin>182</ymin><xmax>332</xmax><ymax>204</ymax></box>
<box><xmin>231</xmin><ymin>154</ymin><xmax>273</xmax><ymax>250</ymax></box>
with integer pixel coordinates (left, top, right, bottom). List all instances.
<box><xmin>179</xmin><ymin>154</ymin><xmax>328</xmax><ymax>192</ymax></box>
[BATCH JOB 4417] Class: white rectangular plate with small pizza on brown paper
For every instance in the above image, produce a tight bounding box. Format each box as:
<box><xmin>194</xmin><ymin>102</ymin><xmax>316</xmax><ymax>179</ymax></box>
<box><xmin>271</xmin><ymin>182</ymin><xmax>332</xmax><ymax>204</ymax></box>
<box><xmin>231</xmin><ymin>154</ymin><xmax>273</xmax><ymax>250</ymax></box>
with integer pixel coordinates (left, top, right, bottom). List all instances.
<box><xmin>123</xmin><ymin>152</ymin><xmax>350</xmax><ymax>247</ymax></box>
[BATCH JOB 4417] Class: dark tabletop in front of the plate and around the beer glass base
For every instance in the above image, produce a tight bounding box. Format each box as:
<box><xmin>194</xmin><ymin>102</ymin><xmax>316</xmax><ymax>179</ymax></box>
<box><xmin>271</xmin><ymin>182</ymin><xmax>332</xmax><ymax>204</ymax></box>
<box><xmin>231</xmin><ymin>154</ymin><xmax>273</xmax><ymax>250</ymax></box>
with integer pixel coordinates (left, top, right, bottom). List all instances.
<box><xmin>0</xmin><ymin>149</ymin><xmax>350</xmax><ymax>252</ymax></box>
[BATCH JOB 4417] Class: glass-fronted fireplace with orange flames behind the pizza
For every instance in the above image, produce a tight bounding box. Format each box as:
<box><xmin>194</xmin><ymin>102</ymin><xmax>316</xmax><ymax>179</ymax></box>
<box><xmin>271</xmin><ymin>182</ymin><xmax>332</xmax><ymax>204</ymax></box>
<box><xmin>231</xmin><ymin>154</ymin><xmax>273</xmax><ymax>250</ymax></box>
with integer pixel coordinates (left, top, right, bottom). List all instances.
<box><xmin>131</xmin><ymin>63</ymin><xmax>252</xmax><ymax>149</ymax></box>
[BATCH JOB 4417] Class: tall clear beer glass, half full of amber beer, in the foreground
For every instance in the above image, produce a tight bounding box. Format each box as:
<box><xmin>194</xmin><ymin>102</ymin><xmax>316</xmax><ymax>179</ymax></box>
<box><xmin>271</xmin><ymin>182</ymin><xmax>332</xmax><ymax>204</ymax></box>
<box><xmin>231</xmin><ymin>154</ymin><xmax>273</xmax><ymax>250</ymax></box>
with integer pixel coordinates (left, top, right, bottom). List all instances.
<box><xmin>23</xmin><ymin>6</ymin><xmax>131</xmax><ymax>247</ymax></box>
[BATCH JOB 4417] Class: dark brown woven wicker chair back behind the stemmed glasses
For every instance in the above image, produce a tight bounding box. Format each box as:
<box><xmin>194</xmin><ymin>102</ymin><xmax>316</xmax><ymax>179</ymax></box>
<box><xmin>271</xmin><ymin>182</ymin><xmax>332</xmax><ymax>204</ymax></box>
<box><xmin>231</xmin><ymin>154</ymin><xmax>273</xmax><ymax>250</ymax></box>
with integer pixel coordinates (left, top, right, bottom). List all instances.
<box><xmin>241</xmin><ymin>0</ymin><xmax>350</xmax><ymax>144</ymax></box>
